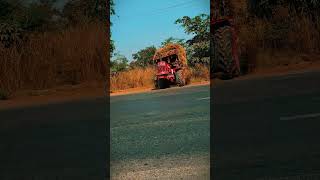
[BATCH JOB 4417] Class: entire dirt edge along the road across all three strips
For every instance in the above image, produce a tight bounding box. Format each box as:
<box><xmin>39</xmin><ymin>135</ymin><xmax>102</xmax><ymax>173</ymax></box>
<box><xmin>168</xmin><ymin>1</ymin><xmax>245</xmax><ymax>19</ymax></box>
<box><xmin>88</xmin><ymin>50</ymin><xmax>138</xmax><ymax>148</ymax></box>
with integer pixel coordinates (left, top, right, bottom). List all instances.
<box><xmin>0</xmin><ymin>61</ymin><xmax>320</xmax><ymax>110</ymax></box>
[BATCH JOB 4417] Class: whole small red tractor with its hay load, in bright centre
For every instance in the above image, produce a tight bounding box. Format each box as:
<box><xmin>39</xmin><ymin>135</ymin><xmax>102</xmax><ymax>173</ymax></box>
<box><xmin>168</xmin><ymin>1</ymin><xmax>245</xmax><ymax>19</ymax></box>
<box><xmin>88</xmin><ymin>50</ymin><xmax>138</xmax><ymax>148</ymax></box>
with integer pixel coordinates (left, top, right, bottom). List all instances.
<box><xmin>153</xmin><ymin>44</ymin><xmax>189</xmax><ymax>89</ymax></box>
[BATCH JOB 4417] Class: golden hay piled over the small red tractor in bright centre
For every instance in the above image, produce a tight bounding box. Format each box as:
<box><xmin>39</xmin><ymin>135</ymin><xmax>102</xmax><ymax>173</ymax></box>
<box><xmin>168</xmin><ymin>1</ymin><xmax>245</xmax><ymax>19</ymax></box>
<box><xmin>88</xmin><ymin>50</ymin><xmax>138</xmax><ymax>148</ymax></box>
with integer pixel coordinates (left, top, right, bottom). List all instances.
<box><xmin>153</xmin><ymin>44</ymin><xmax>187</xmax><ymax>66</ymax></box>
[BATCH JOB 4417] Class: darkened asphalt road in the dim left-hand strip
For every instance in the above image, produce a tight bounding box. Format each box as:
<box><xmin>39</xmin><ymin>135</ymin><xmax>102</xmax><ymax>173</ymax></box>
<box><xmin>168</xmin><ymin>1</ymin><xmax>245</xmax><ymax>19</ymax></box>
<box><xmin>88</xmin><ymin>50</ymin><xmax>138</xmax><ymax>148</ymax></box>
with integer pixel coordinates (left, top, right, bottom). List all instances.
<box><xmin>0</xmin><ymin>98</ymin><xmax>108</xmax><ymax>180</ymax></box>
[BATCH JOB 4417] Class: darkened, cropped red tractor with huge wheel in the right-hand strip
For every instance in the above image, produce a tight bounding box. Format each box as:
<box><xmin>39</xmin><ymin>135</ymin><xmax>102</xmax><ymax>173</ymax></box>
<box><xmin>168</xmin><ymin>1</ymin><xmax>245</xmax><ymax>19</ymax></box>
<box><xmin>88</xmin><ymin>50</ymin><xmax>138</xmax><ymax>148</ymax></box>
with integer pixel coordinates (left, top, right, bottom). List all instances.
<box><xmin>210</xmin><ymin>0</ymin><xmax>240</xmax><ymax>79</ymax></box>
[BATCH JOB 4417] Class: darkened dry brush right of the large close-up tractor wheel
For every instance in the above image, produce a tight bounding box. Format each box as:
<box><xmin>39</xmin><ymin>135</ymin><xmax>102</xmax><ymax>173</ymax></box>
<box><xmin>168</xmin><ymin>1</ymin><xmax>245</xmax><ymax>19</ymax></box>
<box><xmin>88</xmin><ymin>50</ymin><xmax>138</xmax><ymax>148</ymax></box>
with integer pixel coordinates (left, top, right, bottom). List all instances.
<box><xmin>230</xmin><ymin>0</ymin><xmax>320</xmax><ymax>73</ymax></box>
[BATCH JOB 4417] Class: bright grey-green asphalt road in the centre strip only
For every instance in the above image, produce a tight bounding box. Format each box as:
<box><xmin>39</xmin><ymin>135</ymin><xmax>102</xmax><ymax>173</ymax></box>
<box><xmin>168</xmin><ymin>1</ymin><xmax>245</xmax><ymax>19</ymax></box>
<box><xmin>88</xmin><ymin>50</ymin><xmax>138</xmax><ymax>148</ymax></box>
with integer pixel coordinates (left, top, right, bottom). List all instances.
<box><xmin>110</xmin><ymin>85</ymin><xmax>210</xmax><ymax>179</ymax></box>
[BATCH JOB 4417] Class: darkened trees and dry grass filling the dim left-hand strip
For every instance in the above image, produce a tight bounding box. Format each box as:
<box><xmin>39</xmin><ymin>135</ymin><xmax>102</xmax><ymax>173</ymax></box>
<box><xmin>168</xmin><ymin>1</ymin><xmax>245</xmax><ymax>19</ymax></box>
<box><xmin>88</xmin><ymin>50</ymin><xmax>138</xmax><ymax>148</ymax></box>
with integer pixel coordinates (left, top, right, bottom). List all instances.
<box><xmin>0</xmin><ymin>0</ymin><xmax>113</xmax><ymax>99</ymax></box>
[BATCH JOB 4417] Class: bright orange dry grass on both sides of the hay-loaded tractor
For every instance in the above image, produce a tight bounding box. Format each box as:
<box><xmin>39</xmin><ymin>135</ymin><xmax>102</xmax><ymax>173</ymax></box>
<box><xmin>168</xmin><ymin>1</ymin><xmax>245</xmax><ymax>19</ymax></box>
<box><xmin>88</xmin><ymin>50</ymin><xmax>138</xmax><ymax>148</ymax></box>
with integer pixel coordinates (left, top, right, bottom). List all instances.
<box><xmin>110</xmin><ymin>65</ymin><xmax>210</xmax><ymax>92</ymax></box>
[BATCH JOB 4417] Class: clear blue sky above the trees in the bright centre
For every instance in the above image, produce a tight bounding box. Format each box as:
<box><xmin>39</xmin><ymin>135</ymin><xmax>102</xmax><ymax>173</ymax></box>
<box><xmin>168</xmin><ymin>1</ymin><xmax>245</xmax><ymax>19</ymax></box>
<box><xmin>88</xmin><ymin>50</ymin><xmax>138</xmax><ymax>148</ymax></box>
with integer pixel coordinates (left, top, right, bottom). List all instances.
<box><xmin>111</xmin><ymin>0</ymin><xmax>210</xmax><ymax>61</ymax></box>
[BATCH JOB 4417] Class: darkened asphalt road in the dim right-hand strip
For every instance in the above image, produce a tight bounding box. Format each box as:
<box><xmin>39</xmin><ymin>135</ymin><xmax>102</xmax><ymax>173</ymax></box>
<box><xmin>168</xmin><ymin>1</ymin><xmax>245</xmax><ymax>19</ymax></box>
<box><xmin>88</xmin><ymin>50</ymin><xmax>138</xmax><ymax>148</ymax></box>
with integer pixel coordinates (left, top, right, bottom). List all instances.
<box><xmin>211</xmin><ymin>72</ymin><xmax>320</xmax><ymax>180</ymax></box>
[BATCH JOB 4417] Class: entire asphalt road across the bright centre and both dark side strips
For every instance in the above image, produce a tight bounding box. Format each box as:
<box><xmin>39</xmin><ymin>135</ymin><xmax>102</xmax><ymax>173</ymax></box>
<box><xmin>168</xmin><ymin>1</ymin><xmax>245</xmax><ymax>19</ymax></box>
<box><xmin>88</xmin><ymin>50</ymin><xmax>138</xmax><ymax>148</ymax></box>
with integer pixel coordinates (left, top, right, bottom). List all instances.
<box><xmin>0</xmin><ymin>69</ymin><xmax>320</xmax><ymax>180</ymax></box>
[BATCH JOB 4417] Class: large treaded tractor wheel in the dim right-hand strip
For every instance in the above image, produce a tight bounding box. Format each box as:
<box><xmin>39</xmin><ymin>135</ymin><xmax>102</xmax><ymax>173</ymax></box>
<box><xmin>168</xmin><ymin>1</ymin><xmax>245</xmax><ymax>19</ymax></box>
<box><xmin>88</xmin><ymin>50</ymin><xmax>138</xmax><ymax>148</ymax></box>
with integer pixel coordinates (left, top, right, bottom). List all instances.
<box><xmin>213</xmin><ymin>26</ymin><xmax>236</xmax><ymax>79</ymax></box>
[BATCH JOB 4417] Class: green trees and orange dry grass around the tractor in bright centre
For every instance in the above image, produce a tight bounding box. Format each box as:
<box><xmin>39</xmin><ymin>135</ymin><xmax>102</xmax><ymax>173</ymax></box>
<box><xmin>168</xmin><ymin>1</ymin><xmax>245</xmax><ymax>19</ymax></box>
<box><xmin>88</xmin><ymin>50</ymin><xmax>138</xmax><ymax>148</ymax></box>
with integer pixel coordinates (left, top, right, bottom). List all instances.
<box><xmin>110</xmin><ymin>14</ymin><xmax>210</xmax><ymax>92</ymax></box>
